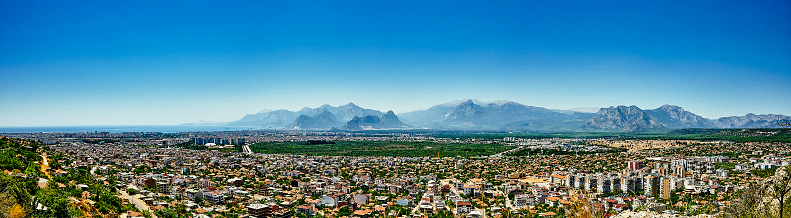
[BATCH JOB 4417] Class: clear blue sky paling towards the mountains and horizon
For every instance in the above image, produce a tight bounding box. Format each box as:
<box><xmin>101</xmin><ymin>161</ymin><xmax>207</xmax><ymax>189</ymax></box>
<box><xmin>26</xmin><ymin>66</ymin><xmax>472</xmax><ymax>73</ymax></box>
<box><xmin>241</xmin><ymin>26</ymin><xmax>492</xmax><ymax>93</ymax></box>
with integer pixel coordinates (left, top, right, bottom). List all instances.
<box><xmin>0</xmin><ymin>1</ymin><xmax>791</xmax><ymax>126</ymax></box>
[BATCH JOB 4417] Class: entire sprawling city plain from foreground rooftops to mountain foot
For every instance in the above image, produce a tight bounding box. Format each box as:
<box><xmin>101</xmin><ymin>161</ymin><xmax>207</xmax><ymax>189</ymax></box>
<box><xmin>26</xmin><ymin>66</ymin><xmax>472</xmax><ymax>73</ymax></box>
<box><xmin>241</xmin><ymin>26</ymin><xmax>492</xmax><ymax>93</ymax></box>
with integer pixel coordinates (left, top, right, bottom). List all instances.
<box><xmin>3</xmin><ymin>130</ymin><xmax>791</xmax><ymax>218</ymax></box>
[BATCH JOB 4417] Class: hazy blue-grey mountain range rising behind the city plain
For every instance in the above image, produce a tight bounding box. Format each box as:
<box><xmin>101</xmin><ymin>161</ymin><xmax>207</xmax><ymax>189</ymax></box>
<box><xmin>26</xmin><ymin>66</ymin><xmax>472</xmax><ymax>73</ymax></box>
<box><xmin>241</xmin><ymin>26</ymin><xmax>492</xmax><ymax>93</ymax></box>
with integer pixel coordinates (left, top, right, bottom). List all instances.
<box><xmin>227</xmin><ymin>100</ymin><xmax>789</xmax><ymax>132</ymax></box>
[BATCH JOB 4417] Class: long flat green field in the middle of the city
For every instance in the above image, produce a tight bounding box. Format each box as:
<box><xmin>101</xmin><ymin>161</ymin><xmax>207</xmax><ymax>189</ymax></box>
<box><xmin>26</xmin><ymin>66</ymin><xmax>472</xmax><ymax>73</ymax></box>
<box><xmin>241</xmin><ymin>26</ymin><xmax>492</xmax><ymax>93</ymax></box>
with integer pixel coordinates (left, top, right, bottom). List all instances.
<box><xmin>250</xmin><ymin>141</ymin><xmax>513</xmax><ymax>157</ymax></box>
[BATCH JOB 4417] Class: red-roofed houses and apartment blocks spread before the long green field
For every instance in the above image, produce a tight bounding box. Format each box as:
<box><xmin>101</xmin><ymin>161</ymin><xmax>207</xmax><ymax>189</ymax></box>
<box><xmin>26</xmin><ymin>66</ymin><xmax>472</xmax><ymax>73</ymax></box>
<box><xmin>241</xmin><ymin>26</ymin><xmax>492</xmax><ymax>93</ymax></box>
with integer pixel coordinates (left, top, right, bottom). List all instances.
<box><xmin>34</xmin><ymin>135</ymin><xmax>789</xmax><ymax>218</ymax></box>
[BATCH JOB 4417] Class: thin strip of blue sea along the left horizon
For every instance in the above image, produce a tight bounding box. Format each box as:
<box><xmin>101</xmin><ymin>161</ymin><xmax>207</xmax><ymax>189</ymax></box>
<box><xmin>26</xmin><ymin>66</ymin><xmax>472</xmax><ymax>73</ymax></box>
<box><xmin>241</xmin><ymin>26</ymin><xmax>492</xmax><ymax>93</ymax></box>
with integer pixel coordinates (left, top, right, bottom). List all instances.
<box><xmin>0</xmin><ymin>125</ymin><xmax>261</xmax><ymax>133</ymax></box>
